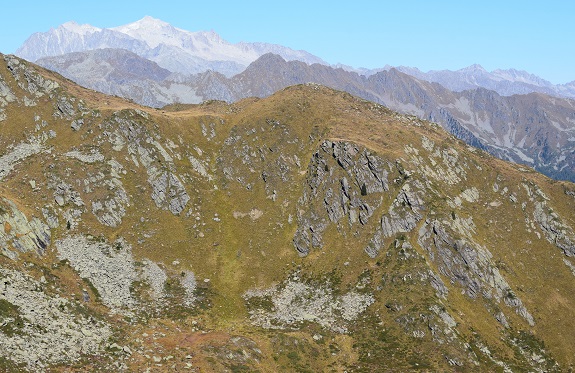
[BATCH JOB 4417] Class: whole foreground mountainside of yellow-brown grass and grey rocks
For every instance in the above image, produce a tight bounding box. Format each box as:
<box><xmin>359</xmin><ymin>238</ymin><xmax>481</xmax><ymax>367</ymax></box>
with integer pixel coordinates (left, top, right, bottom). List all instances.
<box><xmin>0</xmin><ymin>55</ymin><xmax>575</xmax><ymax>372</ymax></box>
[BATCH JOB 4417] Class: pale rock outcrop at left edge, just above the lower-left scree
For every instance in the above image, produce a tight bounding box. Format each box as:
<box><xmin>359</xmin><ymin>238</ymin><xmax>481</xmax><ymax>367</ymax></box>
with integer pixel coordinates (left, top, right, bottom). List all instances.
<box><xmin>0</xmin><ymin>198</ymin><xmax>51</xmax><ymax>259</ymax></box>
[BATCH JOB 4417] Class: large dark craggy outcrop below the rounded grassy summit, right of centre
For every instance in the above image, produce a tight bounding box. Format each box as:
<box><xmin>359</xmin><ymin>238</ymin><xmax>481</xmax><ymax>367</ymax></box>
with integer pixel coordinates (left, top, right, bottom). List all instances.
<box><xmin>293</xmin><ymin>141</ymin><xmax>389</xmax><ymax>255</ymax></box>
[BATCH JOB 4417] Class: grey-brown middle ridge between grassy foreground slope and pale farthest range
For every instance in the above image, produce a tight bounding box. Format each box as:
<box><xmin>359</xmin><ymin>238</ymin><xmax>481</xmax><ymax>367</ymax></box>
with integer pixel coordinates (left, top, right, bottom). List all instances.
<box><xmin>32</xmin><ymin>50</ymin><xmax>575</xmax><ymax>180</ymax></box>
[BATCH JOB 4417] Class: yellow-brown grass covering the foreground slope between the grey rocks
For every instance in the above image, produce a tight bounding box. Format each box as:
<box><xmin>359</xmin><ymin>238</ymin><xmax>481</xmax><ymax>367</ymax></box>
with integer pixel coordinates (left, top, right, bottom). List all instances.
<box><xmin>0</xmin><ymin>58</ymin><xmax>575</xmax><ymax>371</ymax></box>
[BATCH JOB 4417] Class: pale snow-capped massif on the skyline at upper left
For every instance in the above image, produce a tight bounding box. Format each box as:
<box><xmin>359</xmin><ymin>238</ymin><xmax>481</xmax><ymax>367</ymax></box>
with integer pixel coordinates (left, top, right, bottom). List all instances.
<box><xmin>16</xmin><ymin>16</ymin><xmax>324</xmax><ymax>76</ymax></box>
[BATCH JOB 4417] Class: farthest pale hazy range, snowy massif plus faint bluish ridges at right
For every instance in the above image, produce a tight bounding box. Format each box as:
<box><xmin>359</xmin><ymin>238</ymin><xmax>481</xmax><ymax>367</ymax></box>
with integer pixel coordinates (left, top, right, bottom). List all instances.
<box><xmin>16</xmin><ymin>16</ymin><xmax>575</xmax><ymax>98</ymax></box>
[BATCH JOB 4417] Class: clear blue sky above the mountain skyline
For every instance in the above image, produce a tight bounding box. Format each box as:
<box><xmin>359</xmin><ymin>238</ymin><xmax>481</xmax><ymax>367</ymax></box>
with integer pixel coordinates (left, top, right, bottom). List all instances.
<box><xmin>0</xmin><ymin>0</ymin><xmax>575</xmax><ymax>83</ymax></box>
